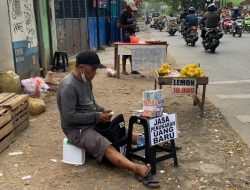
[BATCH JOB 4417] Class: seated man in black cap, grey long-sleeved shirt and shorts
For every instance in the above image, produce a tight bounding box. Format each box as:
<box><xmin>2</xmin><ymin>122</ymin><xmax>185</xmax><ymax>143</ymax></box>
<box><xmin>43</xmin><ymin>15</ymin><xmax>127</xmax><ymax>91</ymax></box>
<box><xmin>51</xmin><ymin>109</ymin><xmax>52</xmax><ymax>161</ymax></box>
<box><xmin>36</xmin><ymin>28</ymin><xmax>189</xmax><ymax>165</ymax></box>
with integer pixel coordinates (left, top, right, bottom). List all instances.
<box><xmin>57</xmin><ymin>51</ymin><xmax>159</xmax><ymax>189</ymax></box>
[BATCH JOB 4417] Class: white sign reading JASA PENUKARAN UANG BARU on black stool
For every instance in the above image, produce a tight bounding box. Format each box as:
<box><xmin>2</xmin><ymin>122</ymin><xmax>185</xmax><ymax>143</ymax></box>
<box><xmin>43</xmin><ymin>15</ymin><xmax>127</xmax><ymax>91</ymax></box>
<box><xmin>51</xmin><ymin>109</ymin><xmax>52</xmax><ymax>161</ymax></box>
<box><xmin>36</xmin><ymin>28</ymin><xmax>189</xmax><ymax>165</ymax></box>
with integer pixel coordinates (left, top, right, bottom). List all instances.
<box><xmin>148</xmin><ymin>113</ymin><xmax>177</xmax><ymax>146</ymax></box>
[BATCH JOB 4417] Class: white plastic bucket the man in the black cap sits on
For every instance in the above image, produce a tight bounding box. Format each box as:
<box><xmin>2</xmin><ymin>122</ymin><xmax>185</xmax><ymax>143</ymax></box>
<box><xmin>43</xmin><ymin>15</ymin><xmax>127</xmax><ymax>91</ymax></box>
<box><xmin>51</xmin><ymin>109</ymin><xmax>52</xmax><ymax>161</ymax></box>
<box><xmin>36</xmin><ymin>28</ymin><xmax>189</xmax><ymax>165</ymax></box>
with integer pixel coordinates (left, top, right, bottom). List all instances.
<box><xmin>62</xmin><ymin>138</ymin><xmax>85</xmax><ymax>165</ymax></box>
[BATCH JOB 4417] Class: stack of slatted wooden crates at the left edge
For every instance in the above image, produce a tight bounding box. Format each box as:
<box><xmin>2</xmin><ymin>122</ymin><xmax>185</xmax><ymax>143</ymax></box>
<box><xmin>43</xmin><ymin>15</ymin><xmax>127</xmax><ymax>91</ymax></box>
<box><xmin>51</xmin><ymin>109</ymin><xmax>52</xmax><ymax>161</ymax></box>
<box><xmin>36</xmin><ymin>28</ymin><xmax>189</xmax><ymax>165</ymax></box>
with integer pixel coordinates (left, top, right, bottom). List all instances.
<box><xmin>0</xmin><ymin>93</ymin><xmax>29</xmax><ymax>152</ymax></box>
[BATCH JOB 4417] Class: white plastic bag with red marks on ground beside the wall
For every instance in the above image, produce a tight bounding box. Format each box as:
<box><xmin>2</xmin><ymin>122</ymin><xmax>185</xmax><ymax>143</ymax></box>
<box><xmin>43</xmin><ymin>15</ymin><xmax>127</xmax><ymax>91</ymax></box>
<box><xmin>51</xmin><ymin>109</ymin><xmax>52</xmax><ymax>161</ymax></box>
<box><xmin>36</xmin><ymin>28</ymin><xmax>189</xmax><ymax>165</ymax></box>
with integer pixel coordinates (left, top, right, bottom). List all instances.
<box><xmin>21</xmin><ymin>77</ymin><xmax>49</xmax><ymax>98</ymax></box>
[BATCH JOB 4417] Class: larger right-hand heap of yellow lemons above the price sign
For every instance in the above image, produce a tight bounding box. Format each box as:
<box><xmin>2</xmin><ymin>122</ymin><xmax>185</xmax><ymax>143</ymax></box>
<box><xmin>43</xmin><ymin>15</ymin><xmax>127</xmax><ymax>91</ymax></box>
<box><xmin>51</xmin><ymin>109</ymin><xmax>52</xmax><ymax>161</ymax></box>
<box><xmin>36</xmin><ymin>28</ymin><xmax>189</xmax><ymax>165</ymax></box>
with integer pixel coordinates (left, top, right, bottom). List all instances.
<box><xmin>178</xmin><ymin>64</ymin><xmax>205</xmax><ymax>77</ymax></box>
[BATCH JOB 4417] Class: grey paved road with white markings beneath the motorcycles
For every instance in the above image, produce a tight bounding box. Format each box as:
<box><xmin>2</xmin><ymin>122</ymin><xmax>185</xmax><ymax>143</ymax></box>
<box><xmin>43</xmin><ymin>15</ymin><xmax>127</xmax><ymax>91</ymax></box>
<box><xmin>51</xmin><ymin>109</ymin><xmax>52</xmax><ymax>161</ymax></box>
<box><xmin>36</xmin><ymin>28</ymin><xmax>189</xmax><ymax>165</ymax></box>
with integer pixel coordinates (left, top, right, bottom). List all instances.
<box><xmin>150</xmin><ymin>29</ymin><xmax>250</xmax><ymax>147</ymax></box>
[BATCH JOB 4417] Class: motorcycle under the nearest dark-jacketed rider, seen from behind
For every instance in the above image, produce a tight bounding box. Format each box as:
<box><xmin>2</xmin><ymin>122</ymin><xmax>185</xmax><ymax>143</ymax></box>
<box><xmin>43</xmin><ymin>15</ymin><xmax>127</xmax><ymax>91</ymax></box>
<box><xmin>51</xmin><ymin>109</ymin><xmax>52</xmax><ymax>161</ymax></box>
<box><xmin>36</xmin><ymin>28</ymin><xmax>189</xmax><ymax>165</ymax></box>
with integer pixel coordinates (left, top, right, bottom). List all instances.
<box><xmin>202</xmin><ymin>27</ymin><xmax>220</xmax><ymax>53</ymax></box>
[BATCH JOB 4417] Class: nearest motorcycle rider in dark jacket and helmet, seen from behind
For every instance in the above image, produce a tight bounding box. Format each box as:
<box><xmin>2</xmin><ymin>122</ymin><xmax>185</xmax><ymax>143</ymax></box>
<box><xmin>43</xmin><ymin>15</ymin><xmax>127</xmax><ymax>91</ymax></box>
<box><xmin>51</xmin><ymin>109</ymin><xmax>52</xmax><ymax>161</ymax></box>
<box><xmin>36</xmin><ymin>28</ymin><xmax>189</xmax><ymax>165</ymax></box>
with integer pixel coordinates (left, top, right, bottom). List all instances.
<box><xmin>201</xmin><ymin>4</ymin><xmax>220</xmax><ymax>40</ymax></box>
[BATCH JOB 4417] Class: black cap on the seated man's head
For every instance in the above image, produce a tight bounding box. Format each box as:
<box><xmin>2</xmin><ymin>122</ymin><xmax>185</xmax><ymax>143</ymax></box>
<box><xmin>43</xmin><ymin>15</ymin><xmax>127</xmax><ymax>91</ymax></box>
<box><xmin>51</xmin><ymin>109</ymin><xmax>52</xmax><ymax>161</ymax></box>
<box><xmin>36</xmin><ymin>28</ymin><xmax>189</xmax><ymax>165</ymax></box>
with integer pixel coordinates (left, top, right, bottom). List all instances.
<box><xmin>76</xmin><ymin>51</ymin><xmax>106</xmax><ymax>69</ymax></box>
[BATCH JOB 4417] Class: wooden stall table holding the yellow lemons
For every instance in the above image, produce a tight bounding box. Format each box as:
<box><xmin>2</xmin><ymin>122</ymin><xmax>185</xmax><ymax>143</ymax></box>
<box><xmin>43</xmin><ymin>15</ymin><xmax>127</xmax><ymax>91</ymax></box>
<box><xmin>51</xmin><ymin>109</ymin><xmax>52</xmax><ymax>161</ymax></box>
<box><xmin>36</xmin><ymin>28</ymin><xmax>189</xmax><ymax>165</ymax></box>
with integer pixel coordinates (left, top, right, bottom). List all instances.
<box><xmin>154</xmin><ymin>71</ymin><xmax>208</xmax><ymax>117</ymax></box>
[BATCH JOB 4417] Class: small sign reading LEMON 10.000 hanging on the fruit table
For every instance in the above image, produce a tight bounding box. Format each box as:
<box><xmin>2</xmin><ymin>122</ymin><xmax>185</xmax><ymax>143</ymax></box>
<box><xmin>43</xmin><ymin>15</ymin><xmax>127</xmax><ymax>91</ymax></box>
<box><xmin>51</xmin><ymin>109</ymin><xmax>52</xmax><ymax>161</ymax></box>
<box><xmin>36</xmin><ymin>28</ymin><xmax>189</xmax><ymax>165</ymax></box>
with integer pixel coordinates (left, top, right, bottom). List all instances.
<box><xmin>171</xmin><ymin>78</ymin><xmax>196</xmax><ymax>95</ymax></box>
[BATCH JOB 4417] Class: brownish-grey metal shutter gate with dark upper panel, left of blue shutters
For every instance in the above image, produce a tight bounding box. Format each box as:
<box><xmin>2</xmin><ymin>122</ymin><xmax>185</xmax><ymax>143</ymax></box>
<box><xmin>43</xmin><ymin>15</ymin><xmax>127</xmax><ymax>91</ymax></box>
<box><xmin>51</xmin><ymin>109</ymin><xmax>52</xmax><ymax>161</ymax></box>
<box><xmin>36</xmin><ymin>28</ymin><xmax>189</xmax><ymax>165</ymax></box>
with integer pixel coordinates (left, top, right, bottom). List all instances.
<box><xmin>54</xmin><ymin>0</ymin><xmax>88</xmax><ymax>55</ymax></box>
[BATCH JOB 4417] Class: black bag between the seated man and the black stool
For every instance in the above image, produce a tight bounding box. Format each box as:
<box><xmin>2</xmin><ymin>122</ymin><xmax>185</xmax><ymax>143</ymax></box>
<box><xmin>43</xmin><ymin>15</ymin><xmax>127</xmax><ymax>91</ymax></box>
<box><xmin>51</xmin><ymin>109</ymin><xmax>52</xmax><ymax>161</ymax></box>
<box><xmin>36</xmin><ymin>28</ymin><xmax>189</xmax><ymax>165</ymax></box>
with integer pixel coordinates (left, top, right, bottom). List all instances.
<box><xmin>95</xmin><ymin>114</ymin><xmax>127</xmax><ymax>151</ymax></box>
